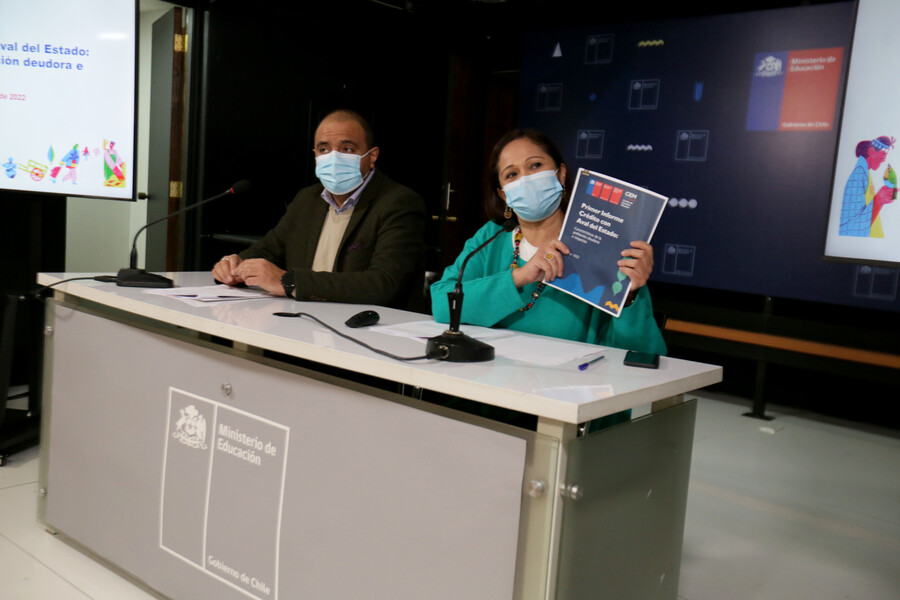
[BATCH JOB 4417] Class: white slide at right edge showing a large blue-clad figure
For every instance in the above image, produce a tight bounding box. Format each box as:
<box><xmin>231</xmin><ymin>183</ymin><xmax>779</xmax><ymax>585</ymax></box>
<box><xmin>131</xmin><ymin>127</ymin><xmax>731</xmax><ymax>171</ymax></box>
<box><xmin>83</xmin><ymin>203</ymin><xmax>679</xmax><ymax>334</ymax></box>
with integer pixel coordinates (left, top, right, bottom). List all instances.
<box><xmin>825</xmin><ymin>0</ymin><xmax>900</xmax><ymax>266</ymax></box>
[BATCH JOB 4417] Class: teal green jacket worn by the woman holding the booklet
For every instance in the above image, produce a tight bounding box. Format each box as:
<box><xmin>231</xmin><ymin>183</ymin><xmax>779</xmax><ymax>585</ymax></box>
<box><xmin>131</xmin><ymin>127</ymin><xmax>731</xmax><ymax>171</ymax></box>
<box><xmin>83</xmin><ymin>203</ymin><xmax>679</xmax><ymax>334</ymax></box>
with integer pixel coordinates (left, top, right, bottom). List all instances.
<box><xmin>431</xmin><ymin>222</ymin><xmax>666</xmax><ymax>354</ymax></box>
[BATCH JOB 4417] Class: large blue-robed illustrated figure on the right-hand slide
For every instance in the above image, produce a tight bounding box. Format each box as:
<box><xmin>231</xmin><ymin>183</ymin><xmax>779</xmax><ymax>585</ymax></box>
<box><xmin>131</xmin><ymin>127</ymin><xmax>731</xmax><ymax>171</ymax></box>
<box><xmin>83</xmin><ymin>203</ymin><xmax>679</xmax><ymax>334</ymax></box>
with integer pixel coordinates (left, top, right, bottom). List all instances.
<box><xmin>838</xmin><ymin>136</ymin><xmax>896</xmax><ymax>237</ymax></box>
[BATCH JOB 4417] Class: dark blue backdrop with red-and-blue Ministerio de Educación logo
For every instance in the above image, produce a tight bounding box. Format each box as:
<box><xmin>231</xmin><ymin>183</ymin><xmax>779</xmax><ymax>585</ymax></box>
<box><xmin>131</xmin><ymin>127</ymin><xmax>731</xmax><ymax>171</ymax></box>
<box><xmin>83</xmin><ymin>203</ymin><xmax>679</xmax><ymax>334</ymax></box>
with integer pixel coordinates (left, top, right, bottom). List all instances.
<box><xmin>519</xmin><ymin>2</ymin><xmax>900</xmax><ymax>311</ymax></box>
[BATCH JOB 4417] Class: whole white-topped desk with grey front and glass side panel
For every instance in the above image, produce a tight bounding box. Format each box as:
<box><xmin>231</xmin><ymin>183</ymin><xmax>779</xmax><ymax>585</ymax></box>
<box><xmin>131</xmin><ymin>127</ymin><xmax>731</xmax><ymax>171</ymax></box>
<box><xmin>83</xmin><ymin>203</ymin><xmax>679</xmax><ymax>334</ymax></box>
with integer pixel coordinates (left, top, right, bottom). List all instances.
<box><xmin>39</xmin><ymin>273</ymin><xmax>721</xmax><ymax>600</ymax></box>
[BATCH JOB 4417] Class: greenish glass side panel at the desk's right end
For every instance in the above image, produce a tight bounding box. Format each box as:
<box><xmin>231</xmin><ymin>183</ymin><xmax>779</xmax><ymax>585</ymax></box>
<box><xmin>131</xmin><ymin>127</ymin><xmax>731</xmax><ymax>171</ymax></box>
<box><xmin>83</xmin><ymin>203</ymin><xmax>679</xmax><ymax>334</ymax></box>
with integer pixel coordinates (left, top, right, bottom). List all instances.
<box><xmin>557</xmin><ymin>400</ymin><xmax>697</xmax><ymax>600</ymax></box>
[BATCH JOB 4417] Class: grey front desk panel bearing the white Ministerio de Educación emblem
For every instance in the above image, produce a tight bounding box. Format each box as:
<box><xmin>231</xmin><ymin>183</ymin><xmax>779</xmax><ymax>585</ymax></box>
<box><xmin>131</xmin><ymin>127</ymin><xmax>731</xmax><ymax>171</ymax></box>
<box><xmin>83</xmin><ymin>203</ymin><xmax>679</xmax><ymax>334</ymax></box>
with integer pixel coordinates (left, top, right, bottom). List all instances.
<box><xmin>46</xmin><ymin>304</ymin><xmax>526</xmax><ymax>600</ymax></box>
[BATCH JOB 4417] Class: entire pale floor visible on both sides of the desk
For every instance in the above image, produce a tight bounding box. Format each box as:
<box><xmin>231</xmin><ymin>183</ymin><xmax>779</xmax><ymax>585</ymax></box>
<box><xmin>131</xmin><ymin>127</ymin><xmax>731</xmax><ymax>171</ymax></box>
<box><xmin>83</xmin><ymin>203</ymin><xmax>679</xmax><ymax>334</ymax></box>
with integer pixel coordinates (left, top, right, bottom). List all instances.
<box><xmin>0</xmin><ymin>393</ymin><xmax>900</xmax><ymax>600</ymax></box>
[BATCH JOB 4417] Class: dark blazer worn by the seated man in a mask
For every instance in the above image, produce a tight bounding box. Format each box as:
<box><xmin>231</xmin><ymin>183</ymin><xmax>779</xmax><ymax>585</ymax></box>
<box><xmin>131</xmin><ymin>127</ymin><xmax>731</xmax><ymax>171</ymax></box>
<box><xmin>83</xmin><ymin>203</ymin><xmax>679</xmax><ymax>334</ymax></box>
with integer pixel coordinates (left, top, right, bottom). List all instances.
<box><xmin>240</xmin><ymin>169</ymin><xmax>425</xmax><ymax>306</ymax></box>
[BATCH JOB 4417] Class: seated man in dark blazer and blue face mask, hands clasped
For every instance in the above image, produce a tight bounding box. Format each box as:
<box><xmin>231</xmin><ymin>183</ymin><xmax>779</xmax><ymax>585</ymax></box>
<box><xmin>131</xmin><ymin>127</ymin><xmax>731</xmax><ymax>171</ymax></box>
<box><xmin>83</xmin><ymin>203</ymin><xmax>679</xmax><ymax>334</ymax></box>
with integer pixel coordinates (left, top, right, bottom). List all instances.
<box><xmin>212</xmin><ymin>110</ymin><xmax>425</xmax><ymax>306</ymax></box>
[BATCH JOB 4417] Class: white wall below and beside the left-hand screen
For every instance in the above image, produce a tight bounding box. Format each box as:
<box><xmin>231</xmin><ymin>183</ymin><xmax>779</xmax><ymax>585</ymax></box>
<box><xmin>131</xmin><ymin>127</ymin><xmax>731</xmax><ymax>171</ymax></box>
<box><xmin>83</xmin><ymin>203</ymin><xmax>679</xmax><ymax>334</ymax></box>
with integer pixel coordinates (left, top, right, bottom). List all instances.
<box><xmin>66</xmin><ymin>3</ymin><xmax>166</xmax><ymax>274</ymax></box>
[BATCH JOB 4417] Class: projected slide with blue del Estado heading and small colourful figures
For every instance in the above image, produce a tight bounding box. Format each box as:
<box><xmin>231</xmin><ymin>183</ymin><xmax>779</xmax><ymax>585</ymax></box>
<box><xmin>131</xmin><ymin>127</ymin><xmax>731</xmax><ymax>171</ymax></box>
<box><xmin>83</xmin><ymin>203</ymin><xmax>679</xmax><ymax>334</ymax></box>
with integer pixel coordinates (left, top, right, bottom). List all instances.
<box><xmin>0</xmin><ymin>0</ymin><xmax>136</xmax><ymax>199</ymax></box>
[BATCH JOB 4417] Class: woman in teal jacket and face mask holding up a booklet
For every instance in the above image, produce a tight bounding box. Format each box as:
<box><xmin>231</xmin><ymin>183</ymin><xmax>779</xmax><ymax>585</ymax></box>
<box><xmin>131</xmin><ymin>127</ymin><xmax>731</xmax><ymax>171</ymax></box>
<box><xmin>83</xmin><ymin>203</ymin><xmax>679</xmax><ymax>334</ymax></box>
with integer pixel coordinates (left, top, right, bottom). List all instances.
<box><xmin>431</xmin><ymin>130</ymin><xmax>666</xmax><ymax>354</ymax></box>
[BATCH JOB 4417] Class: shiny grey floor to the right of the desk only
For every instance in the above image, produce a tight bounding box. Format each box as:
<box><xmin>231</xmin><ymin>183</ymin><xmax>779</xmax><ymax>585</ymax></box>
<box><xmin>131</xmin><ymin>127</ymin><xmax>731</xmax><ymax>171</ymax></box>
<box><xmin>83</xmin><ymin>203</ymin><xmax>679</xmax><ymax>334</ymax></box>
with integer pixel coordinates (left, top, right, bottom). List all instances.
<box><xmin>679</xmin><ymin>397</ymin><xmax>900</xmax><ymax>600</ymax></box>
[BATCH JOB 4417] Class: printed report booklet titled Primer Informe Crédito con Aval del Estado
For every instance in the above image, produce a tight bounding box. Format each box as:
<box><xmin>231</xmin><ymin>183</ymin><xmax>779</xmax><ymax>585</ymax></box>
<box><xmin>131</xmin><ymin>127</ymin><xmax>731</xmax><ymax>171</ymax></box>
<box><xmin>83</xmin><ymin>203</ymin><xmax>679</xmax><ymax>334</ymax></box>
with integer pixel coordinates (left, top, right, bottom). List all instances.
<box><xmin>547</xmin><ymin>169</ymin><xmax>669</xmax><ymax>317</ymax></box>
